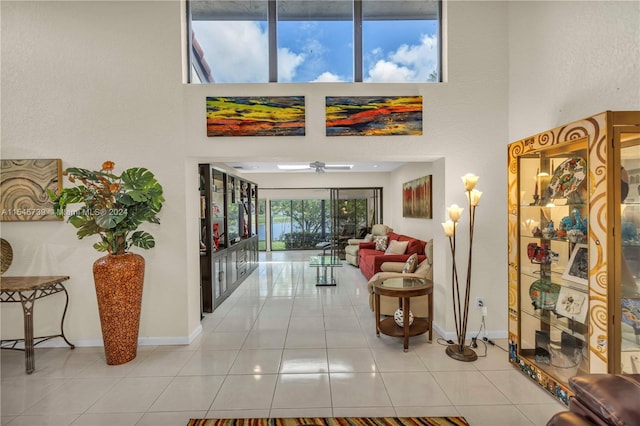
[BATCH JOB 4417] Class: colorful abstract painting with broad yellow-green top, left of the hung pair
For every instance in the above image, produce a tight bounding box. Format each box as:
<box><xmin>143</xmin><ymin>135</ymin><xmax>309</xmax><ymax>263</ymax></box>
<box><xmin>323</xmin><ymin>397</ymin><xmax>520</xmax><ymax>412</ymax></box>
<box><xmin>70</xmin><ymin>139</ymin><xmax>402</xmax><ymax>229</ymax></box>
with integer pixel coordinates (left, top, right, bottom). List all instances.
<box><xmin>207</xmin><ymin>96</ymin><xmax>305</xmax><ymax>136</ymax></box>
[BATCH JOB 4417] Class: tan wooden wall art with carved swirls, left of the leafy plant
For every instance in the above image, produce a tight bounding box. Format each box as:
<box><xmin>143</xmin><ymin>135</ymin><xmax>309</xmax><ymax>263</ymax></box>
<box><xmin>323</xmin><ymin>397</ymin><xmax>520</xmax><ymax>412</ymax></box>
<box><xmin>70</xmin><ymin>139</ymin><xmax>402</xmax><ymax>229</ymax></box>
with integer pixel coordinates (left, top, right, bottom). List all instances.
<box><xmin>0</xmin><ymin>159</ymin><xmax>62</xmax><ymax>222</ymax></box>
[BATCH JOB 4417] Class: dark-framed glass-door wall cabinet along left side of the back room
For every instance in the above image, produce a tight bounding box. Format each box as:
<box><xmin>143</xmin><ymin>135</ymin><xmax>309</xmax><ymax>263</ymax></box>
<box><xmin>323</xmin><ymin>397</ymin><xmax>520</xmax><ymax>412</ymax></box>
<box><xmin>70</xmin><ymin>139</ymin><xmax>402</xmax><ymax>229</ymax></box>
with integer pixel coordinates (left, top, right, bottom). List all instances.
<box><xmin>199</xmin><ymin>164</ymin><xmax>258</xmax><ymax>312</ymax></box>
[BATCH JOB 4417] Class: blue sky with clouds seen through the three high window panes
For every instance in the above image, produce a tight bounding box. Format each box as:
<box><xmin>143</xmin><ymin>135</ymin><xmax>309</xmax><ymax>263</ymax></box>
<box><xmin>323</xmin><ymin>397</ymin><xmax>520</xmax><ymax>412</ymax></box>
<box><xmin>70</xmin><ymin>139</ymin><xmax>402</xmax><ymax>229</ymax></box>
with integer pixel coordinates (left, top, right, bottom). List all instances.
<box><xmin>193</xmin><ymin>21</ymin><xmax>438</xmax><ymax>82</ymax></box>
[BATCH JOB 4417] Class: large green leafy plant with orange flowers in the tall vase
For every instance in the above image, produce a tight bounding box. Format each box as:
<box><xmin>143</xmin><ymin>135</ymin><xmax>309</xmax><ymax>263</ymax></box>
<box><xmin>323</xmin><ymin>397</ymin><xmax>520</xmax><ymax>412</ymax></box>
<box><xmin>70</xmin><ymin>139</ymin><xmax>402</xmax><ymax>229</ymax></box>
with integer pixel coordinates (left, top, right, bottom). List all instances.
<box><xmin>47</xmin><ymin>161</ymin><xmax>164</xmax><ymax>254</ymax></box>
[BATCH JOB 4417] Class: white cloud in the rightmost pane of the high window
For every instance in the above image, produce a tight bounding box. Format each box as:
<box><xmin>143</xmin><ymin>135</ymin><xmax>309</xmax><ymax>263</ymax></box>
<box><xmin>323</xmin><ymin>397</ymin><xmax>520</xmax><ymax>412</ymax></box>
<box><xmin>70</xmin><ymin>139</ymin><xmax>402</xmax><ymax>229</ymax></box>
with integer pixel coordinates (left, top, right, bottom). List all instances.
<box><xmin>366</xmin><ymin>35</ymin><xmax>438</xmax><ymax>82</ymax></box>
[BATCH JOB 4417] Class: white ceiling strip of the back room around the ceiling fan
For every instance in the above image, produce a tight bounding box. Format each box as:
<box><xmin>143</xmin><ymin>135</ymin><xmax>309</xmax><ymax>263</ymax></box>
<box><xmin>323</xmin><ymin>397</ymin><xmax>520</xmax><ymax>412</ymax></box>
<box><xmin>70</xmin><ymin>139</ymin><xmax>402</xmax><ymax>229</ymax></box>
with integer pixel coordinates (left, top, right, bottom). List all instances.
<box><xmin>225</xmin><ymin>159</ymin><xmax>406</xmax><ymax>173</ymax></box>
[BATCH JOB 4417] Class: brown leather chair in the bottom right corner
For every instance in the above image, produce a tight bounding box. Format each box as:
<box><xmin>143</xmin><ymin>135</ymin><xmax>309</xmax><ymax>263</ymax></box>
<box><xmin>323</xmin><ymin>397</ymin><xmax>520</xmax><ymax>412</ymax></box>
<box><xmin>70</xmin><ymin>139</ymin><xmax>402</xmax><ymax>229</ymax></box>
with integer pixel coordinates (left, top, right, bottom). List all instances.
<box><xmin>547</xmin><ymin>374</ymin><xmax>640</xmax><ymax>426</ymax></box>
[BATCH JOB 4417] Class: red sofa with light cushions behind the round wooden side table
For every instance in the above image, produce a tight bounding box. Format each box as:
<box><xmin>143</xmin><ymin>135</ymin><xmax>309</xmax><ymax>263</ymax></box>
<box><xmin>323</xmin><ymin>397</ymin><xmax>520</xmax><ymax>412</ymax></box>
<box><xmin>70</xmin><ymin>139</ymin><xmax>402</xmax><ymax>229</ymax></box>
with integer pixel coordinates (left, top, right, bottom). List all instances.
<box><xmin>358</xmin><ymin>232</ymin><xmax>427</xmax><ymax>280</ymax></box>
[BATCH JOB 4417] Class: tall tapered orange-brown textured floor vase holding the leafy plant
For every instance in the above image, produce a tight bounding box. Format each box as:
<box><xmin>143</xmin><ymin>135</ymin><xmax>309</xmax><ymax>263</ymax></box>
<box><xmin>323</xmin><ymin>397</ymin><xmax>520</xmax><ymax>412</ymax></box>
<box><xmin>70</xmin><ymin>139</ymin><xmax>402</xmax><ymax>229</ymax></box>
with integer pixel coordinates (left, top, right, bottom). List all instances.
<box><xmin>93</xmin><ymin>253</ymin><xmax>144</xmax><ymax>365</ymax></box>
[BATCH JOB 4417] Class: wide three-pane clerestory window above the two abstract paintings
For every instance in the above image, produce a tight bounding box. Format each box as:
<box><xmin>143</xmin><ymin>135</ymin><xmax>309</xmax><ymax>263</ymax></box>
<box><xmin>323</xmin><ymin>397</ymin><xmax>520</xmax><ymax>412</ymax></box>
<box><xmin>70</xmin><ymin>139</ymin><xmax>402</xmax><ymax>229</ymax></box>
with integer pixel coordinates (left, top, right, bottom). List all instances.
<box><xmin>188</xmin><ymin>0</ymin><xmax>441</xmax><ymax>83</ymax></box>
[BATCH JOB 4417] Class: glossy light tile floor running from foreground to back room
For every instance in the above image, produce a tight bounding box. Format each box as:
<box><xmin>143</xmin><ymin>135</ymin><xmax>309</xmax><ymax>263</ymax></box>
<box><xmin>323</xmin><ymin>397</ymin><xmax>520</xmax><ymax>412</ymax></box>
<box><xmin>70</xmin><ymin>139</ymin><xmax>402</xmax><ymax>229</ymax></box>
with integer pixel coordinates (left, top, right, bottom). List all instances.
<box><xmin>0</xmin><ymin>252</ymin><xmax>565</xmax><ymax>426</ymax></box>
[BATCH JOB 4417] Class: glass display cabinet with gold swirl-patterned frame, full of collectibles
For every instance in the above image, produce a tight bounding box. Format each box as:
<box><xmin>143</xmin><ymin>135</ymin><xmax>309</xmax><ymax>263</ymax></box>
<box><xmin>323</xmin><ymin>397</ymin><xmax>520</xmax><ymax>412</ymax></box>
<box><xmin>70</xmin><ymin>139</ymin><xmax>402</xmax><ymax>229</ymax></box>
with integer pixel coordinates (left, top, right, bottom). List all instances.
<box><xmin>508</xmin><ymin>111</ymin><xmax>640</xmax><ymax>404</ymax></box>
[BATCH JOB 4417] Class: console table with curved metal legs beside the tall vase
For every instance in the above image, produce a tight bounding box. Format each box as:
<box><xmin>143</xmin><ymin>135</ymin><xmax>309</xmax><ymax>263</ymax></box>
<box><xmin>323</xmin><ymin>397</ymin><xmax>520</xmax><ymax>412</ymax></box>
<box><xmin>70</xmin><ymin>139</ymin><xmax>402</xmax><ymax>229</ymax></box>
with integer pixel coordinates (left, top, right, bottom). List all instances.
<box><xmin>0</xmin><ymin>276</ymin><xmax>75</xmax><ymax>374</ymax></box>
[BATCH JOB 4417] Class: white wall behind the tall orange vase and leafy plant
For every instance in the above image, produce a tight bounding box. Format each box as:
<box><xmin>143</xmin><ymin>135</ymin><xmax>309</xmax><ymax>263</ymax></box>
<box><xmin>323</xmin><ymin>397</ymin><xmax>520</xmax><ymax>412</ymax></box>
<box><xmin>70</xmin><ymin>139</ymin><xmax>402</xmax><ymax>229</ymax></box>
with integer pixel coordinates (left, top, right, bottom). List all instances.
<box><xmin>1</xmin><ymin>1</ymin><xmax>198</xmax><ymax>345</ymax></box>
